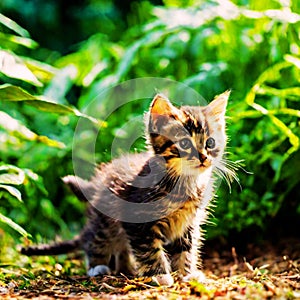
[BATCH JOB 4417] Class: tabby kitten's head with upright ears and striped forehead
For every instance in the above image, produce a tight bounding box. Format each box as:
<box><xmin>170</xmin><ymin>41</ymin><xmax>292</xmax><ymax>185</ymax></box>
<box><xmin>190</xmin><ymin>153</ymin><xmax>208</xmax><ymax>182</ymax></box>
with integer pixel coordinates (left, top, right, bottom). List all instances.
<box><xmin>148</xmin><ymin>92</ymin><xmax>229</xmax><ymax>176</ymax></box>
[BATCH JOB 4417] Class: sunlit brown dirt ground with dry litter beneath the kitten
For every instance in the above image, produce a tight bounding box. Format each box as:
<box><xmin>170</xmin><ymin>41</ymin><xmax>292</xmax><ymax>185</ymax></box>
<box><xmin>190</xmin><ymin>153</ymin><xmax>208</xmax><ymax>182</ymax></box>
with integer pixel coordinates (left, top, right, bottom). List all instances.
<box><xmin>0</xmin><ymin>238</ymin><xmax>300</xmax><ymax>300</ymax></box>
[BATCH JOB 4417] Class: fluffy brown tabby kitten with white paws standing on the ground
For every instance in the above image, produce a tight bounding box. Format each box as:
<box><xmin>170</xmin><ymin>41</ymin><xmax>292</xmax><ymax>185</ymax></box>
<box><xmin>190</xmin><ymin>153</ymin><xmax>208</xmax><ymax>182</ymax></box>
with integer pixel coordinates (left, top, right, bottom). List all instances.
<box><xmin>22</xmin><ymin>92</ymin><xmax>234</xmax><ymax>285</ymax></box>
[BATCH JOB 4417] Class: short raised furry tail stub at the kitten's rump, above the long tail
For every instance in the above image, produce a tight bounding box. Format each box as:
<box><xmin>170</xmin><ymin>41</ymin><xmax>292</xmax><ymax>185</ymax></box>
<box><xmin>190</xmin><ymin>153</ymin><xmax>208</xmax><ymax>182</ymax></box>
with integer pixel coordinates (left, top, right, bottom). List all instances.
<box><xmin>62</xmin><ymin>175</ymin><xmax>95</xmax><ymax>202</ymax></box>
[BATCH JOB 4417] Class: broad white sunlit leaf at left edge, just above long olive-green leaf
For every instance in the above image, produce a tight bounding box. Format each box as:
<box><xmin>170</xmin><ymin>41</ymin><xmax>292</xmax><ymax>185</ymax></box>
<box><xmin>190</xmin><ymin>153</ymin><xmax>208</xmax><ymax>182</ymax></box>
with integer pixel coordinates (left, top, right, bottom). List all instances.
<box><xmin>0</xmin><ymin>50</ymin><xmax>43</xmax><ymax>87</ymax></box>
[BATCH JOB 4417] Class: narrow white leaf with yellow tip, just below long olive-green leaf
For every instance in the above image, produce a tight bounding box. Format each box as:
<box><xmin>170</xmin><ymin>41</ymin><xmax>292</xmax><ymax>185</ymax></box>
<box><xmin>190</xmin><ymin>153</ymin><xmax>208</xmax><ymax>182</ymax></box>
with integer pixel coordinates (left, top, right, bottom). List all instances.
<box><xmin>0</xmin><ymin>111</ymin><xmax>66</xmax><ymax>148</ymax></box>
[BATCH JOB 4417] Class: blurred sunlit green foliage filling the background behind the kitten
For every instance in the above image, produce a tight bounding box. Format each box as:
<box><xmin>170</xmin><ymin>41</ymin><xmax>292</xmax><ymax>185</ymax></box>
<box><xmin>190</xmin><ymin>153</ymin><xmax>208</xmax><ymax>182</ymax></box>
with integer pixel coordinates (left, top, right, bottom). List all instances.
<box><xmin>0</xmin><ymin>0</ymin><xmax>300</xmax><ymax>248</ymax></box>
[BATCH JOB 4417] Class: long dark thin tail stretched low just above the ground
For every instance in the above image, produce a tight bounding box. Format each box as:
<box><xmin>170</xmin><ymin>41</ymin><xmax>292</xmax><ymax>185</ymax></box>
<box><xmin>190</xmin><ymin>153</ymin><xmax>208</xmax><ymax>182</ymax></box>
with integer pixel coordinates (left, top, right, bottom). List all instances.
<box><xmin>21</xmin><ymin>236</ymin><xmax>80</xmax><ymax>256</ymax></box>
